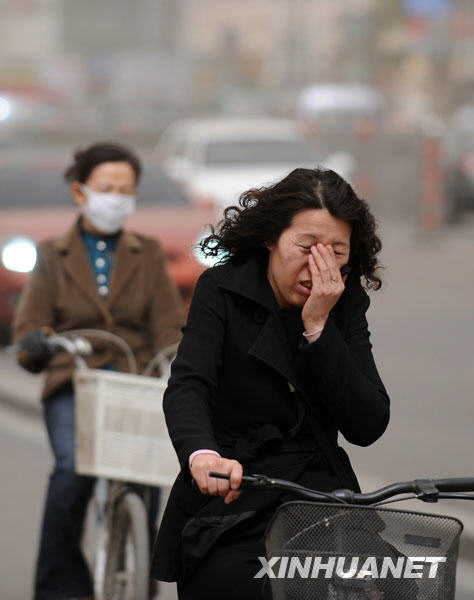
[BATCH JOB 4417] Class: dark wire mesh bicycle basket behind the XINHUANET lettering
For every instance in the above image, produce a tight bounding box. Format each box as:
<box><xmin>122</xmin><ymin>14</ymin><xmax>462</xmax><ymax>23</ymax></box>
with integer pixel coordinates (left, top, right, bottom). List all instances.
<box><xmin>265</xmin><ymin>502</ymin><xmax>463</xmax><ymax>600</ymax></box>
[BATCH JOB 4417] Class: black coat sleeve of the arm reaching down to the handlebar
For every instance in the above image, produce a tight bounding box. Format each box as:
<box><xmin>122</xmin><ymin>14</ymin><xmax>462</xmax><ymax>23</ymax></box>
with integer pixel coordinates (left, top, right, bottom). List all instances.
<box><xmin>163</xmin><ymin>269</ymin><xmax>225</xmax><ymax>474</ymax></box>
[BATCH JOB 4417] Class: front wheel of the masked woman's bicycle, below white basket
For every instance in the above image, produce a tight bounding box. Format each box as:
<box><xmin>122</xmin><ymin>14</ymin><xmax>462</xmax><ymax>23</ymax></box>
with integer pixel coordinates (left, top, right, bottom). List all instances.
<box><xmin>103</xmin><ymin>492</ymin><xmax>149</xmax><ymax>600</ymax></box>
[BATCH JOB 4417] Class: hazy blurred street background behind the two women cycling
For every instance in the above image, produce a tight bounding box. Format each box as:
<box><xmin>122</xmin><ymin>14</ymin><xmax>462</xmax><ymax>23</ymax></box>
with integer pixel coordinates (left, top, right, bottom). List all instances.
<box><xmin>0</xmin><ymin>0</ymin><xmax>474</xmax><ymax>600</ymax></box>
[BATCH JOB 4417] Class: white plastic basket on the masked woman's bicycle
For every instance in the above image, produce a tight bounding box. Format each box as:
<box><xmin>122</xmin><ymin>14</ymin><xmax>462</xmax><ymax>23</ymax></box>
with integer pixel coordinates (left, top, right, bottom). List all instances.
<box><xmin>74</xmin><ymin>369</ymin><xmax>179</xmax><ymax>486</ymax></box>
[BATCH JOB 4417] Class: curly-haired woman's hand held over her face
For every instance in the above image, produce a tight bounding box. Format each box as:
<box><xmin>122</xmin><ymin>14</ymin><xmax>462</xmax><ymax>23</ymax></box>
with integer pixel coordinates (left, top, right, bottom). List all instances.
<box><xmin>301</xmin><ymin>244</ymin><xmax>347</xmax><ymax>333</ymax></box>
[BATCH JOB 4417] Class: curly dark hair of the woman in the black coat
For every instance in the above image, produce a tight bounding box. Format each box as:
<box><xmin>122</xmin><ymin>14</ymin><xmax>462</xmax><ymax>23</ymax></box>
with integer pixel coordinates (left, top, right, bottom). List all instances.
<box><xmin>199</xmin><ymin>168</ymin><xmax>382</xmax><ymax>290</ymax></box>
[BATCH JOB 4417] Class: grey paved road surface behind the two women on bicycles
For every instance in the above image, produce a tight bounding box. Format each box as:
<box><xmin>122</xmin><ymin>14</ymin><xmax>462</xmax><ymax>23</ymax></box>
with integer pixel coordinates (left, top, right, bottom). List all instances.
<box><xmin>0</xmin><ymin>224</ymin><xmax>474</xmax><ymax>600</ymax></box>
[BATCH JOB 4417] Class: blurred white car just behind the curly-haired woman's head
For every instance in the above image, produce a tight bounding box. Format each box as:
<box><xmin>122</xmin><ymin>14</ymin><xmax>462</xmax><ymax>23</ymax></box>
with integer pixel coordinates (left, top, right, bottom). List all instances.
<box><xmin>154</xmin><ymin>118</ymin><xmax>349</xmax><ymax>215</ymax></box>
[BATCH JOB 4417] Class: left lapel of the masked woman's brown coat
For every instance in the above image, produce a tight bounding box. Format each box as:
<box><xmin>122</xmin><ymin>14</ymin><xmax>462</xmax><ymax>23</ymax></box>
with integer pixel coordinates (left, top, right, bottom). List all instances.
<box><xmin>56</xmin><ymin>221</ymin><xmax>112</xmax><ymax>323</ymax></box>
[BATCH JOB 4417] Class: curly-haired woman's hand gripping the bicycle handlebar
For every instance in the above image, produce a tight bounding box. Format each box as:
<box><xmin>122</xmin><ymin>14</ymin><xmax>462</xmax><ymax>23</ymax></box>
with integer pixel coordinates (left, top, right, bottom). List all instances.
<box><xmin>190</xmin><ymin>454</ymin><xmax>243</xmax><ymax>504</ymax></box>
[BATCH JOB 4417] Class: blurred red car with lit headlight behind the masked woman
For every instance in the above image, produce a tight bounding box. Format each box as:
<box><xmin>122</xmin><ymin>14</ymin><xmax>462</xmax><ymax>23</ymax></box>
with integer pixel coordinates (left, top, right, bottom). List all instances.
<box><xmin>0</xmin><ymin>155</ymin><xmax>210</xmax><ymax>339</ymax></box>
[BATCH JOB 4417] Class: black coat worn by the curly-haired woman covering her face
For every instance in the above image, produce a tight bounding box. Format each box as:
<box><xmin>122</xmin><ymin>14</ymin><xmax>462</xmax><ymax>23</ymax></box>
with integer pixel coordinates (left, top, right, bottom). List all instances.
<box><xmin>152</xmin><ymin>252</ymin><xmax>389</xmax><ymax>581</ymax></box>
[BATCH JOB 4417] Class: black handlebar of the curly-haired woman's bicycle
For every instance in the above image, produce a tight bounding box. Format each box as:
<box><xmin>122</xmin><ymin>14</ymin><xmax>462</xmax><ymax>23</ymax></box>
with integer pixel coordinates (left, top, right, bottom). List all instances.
<box><xmin>209</xmin><ymin>471</ymin><xmax>474</xmax><ymax>505</ymax></box>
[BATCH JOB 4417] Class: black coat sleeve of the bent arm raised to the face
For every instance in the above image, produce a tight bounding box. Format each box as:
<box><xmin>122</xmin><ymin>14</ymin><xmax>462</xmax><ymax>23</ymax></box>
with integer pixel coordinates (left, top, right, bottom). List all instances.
<box><xmin>297</xmin><ymin>282</ymin><xmax>390</xmax><ymax>446</ymax></box>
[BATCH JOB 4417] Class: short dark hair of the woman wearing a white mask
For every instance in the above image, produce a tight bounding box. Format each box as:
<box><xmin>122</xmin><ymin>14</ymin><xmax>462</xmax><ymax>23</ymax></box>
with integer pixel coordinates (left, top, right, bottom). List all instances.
<box><xmin>64</xmin><ymin>142</ymin><xmax>142</xmax><ymax>183</ymax></box>
